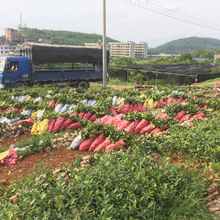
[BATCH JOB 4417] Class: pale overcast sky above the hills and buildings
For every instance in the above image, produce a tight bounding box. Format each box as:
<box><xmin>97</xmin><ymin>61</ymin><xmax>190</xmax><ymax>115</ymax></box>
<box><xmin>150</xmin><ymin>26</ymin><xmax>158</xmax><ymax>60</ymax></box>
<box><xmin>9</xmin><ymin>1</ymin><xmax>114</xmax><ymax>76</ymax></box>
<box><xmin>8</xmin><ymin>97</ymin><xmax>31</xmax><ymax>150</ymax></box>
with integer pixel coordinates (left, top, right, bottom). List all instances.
<box><xmin>0</xmin><ymin>0</ymin><xmax>220</xmax><ymax>48</ymax></box>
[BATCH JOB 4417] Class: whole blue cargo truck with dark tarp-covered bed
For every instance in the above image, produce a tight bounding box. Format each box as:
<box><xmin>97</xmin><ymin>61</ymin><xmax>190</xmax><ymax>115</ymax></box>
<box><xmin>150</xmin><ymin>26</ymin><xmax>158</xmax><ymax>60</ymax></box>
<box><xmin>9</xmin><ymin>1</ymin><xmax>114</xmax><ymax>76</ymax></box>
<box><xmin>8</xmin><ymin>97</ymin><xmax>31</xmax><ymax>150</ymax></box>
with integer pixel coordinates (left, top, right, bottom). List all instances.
<box><xmin>0</xmin><ymin>43</ymin><xmax>109</xmax><ymax>90</ymax></box>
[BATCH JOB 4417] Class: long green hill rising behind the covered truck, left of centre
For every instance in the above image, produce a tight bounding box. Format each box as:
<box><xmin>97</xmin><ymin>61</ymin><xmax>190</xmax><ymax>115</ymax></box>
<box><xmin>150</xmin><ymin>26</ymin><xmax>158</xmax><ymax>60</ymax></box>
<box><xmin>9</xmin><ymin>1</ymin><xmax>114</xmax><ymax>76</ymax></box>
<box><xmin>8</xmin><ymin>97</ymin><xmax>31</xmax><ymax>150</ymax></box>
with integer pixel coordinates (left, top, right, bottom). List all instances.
<box><xmin>19</xmin><ymin>27</ymin><xmax>116</xmax><ymax>46</ymax></box>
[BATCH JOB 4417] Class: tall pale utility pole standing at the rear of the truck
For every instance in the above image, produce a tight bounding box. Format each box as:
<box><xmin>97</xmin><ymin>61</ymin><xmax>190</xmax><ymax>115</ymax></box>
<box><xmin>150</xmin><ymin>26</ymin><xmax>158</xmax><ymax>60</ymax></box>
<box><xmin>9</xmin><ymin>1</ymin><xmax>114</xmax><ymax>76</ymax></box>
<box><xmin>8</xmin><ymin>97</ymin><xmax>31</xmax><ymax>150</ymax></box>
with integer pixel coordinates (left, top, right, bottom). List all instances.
<box><xmin>102</xmin><ymin>0</ymin><xmax>107</xmax><ymax>89</ymax></box>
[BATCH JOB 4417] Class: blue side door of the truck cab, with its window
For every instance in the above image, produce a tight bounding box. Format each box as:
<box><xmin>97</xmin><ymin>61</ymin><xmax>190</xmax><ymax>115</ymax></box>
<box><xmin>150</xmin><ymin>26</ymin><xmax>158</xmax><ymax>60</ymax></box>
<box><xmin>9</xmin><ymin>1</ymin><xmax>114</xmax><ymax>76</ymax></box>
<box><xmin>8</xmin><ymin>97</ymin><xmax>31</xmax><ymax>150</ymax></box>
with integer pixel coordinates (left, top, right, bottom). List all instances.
<box><xmin>5</xmin><ymin>58</ymin><xmax>21</xmax><ymax>83</ymax></box>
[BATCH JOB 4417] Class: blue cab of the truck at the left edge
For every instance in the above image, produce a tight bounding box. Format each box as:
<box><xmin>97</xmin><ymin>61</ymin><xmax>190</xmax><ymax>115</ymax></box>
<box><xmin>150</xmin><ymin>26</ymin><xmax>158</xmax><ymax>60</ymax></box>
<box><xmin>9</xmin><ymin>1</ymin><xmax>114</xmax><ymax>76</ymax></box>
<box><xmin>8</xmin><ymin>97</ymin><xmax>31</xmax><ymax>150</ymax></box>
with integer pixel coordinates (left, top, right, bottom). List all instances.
<box><xmin>0</xmin><ymin>57</ymin><xmax>30</xmax><ymax>89</ymax></box>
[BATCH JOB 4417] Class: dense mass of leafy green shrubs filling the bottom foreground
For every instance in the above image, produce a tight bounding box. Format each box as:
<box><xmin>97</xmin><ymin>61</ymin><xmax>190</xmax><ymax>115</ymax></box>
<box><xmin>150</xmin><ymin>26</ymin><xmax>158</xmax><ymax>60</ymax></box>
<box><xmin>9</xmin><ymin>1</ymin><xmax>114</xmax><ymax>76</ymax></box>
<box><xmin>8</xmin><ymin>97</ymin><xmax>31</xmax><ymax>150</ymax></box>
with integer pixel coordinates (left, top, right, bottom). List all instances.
<box><xmin>0</xmin><ymin>150</ymin><xmax>211</xmax><ymax>220</ymax></box>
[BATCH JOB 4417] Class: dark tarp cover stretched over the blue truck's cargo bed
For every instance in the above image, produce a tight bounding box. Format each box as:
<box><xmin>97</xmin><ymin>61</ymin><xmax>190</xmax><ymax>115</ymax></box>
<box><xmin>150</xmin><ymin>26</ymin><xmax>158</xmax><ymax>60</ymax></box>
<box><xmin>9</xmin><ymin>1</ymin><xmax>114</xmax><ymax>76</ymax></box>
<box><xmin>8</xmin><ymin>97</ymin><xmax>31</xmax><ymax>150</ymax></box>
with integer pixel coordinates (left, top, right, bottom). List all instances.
<box><xmin>21</xmin><ymin>44</ymin><xmax>108</xmax><ymax>65</ymax></box>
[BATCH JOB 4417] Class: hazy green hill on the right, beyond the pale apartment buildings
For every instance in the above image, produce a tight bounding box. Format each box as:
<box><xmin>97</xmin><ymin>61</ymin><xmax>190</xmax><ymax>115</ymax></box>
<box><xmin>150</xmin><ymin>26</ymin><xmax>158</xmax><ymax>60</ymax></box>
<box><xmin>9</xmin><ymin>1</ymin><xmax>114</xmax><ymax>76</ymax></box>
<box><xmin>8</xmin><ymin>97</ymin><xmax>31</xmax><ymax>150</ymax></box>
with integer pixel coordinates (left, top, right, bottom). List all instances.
<box><xmin>148</xmin><ymin>37</ymin><xmax>220</xmax><ymax>55</ymax></box>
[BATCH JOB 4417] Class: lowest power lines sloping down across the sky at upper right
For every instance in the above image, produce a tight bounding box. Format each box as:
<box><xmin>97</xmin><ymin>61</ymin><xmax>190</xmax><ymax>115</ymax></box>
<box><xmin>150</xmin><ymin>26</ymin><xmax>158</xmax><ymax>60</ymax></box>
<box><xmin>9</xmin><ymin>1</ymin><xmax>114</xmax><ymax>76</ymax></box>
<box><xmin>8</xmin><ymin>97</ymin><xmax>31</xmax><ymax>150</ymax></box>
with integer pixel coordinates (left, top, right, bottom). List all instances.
<box><xmin>124</xmin><ymin>0</ymin><xmax>220</xmax><ymax>31</ymax></box>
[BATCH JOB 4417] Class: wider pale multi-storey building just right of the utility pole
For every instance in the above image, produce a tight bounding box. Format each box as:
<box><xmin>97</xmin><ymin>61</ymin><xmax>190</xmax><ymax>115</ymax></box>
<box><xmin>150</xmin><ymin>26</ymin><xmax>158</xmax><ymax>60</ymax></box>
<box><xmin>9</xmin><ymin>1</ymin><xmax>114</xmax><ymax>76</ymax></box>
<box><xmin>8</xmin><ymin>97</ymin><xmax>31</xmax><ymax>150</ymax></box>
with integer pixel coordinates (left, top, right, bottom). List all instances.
<box><xmin>108</xmin><ymin>41</ymin><xmax>135</xmax><ymax>59</ymax></box>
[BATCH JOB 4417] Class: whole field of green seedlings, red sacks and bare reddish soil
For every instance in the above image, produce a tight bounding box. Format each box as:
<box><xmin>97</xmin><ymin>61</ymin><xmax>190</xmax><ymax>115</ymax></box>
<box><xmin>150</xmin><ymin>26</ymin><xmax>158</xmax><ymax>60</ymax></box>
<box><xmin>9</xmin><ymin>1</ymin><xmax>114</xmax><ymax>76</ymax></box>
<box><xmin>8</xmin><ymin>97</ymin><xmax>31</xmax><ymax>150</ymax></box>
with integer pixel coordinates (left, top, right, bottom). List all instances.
<box><xmin>0</xmin><ymin>86</ymin><xmax>220</xmax><ymax>219</ymax></box>
